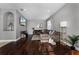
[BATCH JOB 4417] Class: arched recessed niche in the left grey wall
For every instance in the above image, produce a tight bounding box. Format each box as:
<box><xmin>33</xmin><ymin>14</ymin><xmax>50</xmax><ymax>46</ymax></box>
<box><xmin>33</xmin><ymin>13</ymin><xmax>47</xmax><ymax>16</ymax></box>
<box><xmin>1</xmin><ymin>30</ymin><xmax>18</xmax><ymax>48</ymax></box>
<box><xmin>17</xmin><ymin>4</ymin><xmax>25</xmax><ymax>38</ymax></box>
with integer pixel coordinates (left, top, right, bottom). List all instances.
<box><xmin>3</xmin><ymin>12</ymin><xmax>14</xmax><ymax>31</ymax></box>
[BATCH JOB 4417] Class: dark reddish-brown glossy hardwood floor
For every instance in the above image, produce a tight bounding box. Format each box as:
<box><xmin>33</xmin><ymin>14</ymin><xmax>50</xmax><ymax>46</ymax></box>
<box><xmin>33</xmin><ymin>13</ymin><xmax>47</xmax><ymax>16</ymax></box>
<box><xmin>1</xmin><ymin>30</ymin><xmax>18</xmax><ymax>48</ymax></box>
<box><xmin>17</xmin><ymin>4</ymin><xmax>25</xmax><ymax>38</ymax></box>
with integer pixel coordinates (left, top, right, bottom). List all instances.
<box><xmin>0</xmin><ymin>38</ymin><xmax>70</xmax><ymax>55</ymax></box>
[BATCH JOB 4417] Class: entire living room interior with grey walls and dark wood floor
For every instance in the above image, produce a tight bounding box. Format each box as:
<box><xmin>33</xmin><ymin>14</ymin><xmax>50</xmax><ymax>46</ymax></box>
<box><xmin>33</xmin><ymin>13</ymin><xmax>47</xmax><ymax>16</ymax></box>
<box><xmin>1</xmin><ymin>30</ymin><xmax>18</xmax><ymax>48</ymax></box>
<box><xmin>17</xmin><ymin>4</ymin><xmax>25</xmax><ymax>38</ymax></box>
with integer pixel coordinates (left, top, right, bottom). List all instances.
<box><xmin>0</xmin><ymin>3</ymin><xmax>79</xmax><ymax>55</ymax></box>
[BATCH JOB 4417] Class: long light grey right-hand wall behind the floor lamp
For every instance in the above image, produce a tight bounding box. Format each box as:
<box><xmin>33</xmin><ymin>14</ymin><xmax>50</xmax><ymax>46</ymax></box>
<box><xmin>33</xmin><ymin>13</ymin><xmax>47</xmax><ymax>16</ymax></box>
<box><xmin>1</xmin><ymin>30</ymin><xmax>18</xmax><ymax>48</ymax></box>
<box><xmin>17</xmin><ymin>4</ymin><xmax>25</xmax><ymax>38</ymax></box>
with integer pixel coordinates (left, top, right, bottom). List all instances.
<box><xmin>52</xmin><ymin>4</ymin><xmax>79</xmax><ymax>35</ymax></box>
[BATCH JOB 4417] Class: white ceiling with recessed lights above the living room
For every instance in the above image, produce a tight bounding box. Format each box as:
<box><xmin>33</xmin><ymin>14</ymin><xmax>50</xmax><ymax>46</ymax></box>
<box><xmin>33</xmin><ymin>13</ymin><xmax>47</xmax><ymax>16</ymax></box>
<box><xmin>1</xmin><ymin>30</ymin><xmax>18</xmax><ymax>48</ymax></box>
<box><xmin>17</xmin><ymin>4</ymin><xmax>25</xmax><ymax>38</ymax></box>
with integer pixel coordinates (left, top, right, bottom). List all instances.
<box><xmin>0</xmin><ymin>3</ymin><xmax>65</xmax><ymax>20</ymax></box>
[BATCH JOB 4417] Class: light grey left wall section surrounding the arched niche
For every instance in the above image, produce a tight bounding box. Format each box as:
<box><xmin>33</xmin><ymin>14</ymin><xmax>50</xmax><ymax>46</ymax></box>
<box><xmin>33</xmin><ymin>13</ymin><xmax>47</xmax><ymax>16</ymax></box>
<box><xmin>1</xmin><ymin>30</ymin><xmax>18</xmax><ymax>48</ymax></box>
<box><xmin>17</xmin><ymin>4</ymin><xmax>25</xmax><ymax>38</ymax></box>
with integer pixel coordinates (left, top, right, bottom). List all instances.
<box><xmin>0</xmin><ymin>8</ymin><xmax>16</xmax><ymax>40</ymax></box>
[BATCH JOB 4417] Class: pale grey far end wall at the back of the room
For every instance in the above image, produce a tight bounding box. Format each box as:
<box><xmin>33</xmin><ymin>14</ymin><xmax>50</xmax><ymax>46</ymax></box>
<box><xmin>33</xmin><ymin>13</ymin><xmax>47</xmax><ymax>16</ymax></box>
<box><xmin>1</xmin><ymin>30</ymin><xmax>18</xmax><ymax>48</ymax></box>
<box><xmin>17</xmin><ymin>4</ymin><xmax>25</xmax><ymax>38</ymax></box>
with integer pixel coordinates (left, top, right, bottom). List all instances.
<box><xmin>27</xmin><ymin>20</ymin><xmax>46</xmax><ymax>34</ymax></box>
